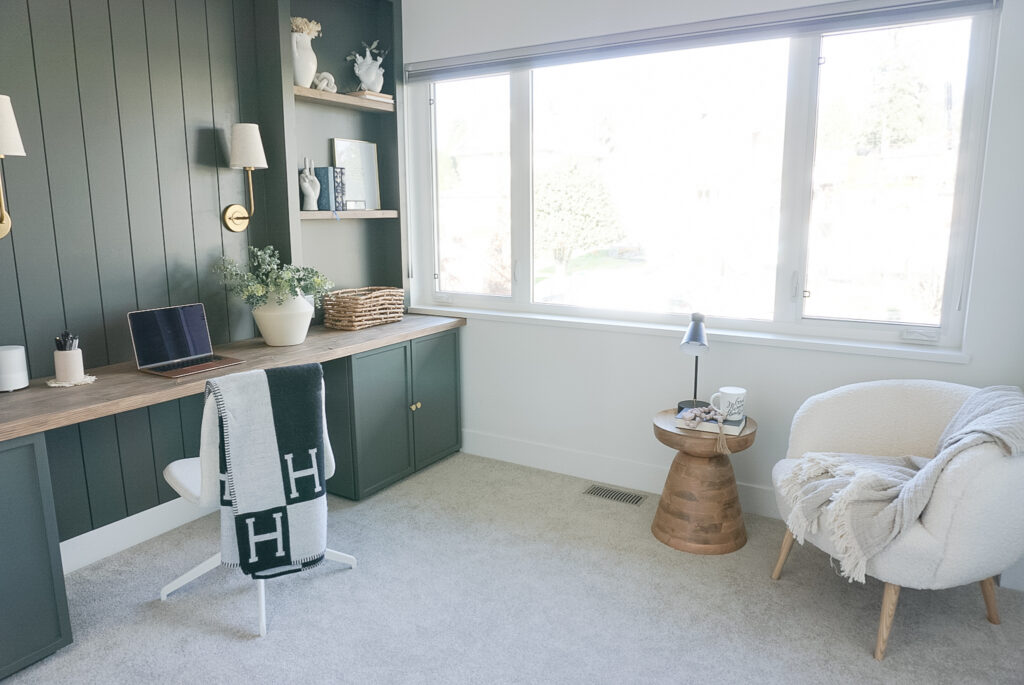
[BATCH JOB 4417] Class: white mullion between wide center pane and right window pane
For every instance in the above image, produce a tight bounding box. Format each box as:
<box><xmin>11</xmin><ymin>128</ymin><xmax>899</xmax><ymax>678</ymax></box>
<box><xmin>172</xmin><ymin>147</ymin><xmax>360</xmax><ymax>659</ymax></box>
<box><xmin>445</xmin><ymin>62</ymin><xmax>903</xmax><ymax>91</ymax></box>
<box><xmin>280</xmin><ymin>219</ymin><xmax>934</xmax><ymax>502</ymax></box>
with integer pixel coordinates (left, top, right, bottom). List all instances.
<box><xmin>775</xmin><ymin>34</ymin><xmax>821</xmax><ymax>322</ymax></box>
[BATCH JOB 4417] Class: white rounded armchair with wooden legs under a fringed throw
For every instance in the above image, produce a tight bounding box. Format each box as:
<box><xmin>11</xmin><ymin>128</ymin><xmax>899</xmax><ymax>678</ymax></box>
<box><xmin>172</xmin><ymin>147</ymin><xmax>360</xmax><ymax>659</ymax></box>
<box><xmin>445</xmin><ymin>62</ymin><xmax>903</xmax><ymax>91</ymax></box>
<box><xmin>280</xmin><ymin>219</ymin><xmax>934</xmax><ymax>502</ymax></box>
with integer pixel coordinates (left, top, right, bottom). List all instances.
<box><xmin>772</xmin><ymin>380</ymin><xmax>1024</xmax><ymax>659</ymax></box>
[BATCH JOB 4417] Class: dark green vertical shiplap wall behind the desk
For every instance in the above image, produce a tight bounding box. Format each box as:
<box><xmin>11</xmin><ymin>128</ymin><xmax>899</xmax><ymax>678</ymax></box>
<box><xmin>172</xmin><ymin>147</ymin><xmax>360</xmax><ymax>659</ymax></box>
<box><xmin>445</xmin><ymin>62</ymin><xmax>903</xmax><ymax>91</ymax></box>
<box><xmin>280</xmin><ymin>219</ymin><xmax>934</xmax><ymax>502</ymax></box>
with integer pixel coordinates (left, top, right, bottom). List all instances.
<box><xmin>0</xmin><ymin>0</ymin><xmax>260</xmax><ymax>540</ymax></box>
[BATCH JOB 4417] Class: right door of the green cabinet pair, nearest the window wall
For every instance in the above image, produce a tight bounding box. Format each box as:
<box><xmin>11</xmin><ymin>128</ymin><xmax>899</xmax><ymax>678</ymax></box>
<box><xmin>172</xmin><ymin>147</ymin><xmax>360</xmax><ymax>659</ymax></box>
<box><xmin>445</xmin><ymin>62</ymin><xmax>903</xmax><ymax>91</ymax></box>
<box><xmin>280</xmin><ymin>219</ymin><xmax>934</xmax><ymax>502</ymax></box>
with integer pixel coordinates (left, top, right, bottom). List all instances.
<box><xmin>412</xmin><ymin>331</ymin><xmax>462</xmax><ymax>469</ymax></box>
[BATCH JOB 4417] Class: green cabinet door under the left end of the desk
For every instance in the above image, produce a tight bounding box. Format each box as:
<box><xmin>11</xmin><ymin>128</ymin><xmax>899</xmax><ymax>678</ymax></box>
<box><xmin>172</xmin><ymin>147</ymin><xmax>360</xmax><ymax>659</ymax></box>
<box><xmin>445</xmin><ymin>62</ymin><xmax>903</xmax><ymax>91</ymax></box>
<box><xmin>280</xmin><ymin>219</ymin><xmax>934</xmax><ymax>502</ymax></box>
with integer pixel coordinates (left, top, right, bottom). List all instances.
<box><xmin>0</xmin><ymin>433</ymin><xmax>71</xmax><ymax>679</ymax></box>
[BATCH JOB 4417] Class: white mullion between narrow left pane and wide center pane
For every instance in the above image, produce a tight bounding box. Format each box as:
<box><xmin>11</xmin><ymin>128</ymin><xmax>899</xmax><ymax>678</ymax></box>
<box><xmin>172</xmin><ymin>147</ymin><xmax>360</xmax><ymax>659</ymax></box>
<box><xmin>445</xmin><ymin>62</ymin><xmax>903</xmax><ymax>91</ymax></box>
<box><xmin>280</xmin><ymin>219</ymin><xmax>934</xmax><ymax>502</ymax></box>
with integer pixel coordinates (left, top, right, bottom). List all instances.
<box><xmin>509</xmin><ymin>70</ymin><xmax>534</xmax><ymax>305</ymax></box>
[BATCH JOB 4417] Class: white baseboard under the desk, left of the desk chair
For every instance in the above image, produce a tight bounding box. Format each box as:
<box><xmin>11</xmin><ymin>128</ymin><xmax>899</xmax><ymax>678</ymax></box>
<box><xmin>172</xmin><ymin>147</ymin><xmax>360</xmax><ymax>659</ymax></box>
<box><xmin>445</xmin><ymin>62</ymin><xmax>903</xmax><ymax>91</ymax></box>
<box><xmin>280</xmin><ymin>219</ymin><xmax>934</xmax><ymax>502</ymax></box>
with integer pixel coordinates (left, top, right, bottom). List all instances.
<box><xmin>60</xmin><ymin>498</ymin><xmax>216</xmax><ymax>574</ymax></box>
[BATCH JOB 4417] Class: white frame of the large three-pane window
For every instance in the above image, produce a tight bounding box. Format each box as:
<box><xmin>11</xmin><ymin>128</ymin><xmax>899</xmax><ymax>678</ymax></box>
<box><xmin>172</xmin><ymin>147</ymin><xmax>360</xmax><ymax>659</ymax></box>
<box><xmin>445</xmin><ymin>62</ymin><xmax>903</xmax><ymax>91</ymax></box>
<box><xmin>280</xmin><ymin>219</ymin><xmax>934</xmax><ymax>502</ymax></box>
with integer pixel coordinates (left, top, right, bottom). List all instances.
<box><xmin>406</xmin><ymin>8</ymin><xmax>997</xmax><ymax>349</ymax></box>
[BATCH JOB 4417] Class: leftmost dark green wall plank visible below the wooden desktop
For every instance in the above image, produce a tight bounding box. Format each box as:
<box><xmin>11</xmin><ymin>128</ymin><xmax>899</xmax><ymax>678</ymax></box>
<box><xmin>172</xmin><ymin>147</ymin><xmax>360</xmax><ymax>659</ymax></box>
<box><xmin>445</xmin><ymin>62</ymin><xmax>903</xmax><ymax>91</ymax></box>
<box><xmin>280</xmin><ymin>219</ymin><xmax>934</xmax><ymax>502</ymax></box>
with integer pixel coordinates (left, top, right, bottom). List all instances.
<box><xmin>46</xmin><ymin>426</ymin><xmax>92</xmax><ymax>541</ymax></box>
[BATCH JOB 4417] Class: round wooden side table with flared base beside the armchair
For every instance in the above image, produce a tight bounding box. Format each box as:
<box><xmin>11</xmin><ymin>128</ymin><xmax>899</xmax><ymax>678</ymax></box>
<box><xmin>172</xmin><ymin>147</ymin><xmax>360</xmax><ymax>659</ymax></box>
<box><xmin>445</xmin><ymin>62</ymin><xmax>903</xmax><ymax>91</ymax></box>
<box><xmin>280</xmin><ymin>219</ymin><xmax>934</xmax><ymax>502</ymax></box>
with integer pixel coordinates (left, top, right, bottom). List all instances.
<box><xmin>650</xmin><ymin>410</ymin><xmax>758</xmax><ymax>554</ymax></box>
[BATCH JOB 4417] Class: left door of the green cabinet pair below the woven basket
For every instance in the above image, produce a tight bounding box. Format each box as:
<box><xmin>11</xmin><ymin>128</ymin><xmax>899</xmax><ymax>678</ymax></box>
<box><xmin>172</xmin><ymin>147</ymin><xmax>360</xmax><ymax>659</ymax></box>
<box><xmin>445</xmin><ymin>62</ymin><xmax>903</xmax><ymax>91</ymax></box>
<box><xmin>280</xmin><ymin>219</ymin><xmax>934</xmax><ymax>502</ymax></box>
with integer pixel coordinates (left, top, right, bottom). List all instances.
<box><xmin>352</xmin><ymin>343</ymin><xmax>415</xmax><ymax>499</ymax></box>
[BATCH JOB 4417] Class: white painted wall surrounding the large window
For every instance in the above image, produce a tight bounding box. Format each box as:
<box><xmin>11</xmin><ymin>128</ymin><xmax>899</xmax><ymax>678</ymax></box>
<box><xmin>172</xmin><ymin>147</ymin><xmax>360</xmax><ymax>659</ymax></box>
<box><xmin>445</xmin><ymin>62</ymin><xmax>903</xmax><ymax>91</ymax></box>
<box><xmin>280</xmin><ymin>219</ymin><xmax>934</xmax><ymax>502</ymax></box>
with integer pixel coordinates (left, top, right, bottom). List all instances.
<box><xmin>406</xmin><ymin>0</ymin><xmax>1024</xmax><ymax>589</ymax></box>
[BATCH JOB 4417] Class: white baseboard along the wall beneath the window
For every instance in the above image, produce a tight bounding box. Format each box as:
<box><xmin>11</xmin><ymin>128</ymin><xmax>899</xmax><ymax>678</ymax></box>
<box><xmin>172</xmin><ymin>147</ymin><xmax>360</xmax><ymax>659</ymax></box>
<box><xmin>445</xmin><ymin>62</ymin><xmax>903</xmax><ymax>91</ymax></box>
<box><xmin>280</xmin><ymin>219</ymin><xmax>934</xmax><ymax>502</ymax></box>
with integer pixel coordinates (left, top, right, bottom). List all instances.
<box><xmin>462</xmin><ymin>430</ymin><xmax>778</xmax><ymax>518</ymax></box>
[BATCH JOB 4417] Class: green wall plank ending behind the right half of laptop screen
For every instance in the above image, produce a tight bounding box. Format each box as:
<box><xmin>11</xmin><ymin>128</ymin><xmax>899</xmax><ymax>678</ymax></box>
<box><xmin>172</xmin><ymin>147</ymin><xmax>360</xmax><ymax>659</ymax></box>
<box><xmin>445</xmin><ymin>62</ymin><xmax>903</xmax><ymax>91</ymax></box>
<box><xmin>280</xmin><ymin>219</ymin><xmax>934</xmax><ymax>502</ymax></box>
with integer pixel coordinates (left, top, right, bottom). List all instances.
<box><xmin>144</xmin><ymin>0</ymin><xmax>199</xmax><ymax>304</ymax></box>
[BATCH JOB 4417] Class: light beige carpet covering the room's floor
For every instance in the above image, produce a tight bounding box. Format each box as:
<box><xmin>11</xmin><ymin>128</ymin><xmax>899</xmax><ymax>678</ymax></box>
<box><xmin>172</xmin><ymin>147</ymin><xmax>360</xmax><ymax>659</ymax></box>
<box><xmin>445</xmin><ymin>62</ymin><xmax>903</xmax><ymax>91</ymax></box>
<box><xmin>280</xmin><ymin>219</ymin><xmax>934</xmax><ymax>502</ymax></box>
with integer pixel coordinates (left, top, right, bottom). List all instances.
<box><xmin>8</xmin><ymin>455</ymin><xmax>1024</xmax><ymax>685</ymax></box>
